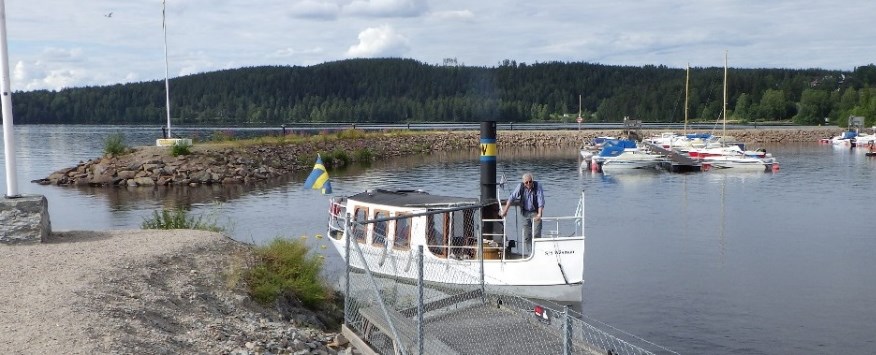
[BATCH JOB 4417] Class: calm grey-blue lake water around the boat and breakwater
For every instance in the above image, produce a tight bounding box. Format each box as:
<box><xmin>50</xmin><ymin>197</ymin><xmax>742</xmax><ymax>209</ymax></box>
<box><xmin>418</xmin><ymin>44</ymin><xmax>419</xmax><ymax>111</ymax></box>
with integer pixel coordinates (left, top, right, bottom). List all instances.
<box><xmin>0</xmin><ymin>125</ymin><xmax>876</xmax><ymax>354</ymax></box>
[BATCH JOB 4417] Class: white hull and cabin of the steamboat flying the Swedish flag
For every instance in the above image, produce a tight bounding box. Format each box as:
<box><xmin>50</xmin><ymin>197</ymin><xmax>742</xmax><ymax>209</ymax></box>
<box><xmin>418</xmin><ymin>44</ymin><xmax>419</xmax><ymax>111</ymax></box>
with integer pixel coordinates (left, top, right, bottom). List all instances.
<box><xmin>328</xmin><ymin>190</ymin><xmax>584</xmax><ymax>302</ymax></box>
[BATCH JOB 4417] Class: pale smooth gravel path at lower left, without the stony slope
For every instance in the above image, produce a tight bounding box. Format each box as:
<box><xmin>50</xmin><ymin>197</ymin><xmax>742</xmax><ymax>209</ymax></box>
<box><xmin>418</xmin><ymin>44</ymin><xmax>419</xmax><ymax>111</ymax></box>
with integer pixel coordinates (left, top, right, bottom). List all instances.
<box><xmin>0</xmin><ymin>230</ymin><xmax>239</xmax><ymax>354</ymax></box>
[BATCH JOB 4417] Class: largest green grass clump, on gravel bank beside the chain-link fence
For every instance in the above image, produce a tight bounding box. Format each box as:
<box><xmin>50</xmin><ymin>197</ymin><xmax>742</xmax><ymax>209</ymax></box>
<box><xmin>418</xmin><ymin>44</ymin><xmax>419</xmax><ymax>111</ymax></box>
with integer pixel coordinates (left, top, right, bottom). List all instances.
<box><xmin>246</xmin><ymin>238</ymin><xmax>334</xmax><ymax>308</ymax></box>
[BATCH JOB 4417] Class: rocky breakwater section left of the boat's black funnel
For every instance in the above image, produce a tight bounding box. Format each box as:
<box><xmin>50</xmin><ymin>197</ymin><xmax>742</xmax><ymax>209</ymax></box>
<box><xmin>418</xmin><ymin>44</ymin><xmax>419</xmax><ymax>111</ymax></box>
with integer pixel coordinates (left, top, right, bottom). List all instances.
<box><xmin>32</xmin><ymin>133</ymin><xmax>477</xmax><ymax>187</ymax></box>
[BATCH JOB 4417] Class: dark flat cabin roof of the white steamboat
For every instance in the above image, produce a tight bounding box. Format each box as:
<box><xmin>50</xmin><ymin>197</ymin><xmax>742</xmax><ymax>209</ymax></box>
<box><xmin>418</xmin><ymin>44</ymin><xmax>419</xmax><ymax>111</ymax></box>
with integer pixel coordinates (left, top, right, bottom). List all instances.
<box><xmin>347</xmin><ymin>189</ymin><xmax>480</xmax><ymax>208</ymax></box>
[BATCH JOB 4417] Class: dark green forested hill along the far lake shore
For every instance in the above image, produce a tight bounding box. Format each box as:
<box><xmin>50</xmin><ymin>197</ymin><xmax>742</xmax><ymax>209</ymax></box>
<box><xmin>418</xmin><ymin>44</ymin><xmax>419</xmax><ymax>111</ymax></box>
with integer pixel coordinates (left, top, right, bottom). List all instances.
<box><xmin>13</xmin><ymin>59</ymin><xmax>876</xmax><ymax>126</ymax></box>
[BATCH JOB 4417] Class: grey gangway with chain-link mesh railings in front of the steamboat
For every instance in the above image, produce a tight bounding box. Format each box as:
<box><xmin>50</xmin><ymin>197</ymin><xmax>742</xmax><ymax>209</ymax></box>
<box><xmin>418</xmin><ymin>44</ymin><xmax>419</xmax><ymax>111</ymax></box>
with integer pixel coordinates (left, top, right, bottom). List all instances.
<box><xmin>342</xmin><ymin>206</ymin><xmax>674</xmax><ymax>355</ymax></box>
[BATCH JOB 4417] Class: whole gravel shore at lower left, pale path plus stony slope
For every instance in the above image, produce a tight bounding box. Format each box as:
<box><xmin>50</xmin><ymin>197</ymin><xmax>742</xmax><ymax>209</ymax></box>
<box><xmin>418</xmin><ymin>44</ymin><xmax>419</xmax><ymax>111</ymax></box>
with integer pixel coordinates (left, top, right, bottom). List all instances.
<box><xmin>0</xmin><ymin>230</ymin><xmax>350</xmax><ymax>354</ymax></box>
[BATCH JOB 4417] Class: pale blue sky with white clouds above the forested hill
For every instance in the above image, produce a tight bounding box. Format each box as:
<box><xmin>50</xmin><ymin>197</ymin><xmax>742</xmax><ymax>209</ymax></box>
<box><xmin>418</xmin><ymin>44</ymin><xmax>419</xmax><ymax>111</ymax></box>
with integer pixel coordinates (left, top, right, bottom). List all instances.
<box><xmin>5</xmin><ymin>0</ymin><xmax>876</xmax><ymax>91</ymax></box>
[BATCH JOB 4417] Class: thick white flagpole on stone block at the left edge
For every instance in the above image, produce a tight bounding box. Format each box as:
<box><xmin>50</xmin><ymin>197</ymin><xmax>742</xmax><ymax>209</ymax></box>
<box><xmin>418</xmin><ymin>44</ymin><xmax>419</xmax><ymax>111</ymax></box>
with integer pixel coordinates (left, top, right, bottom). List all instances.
<box><xmin>0</xmin><ymin>0</ymin><xmax>20</xmax><ymax>198</ymax></box>
